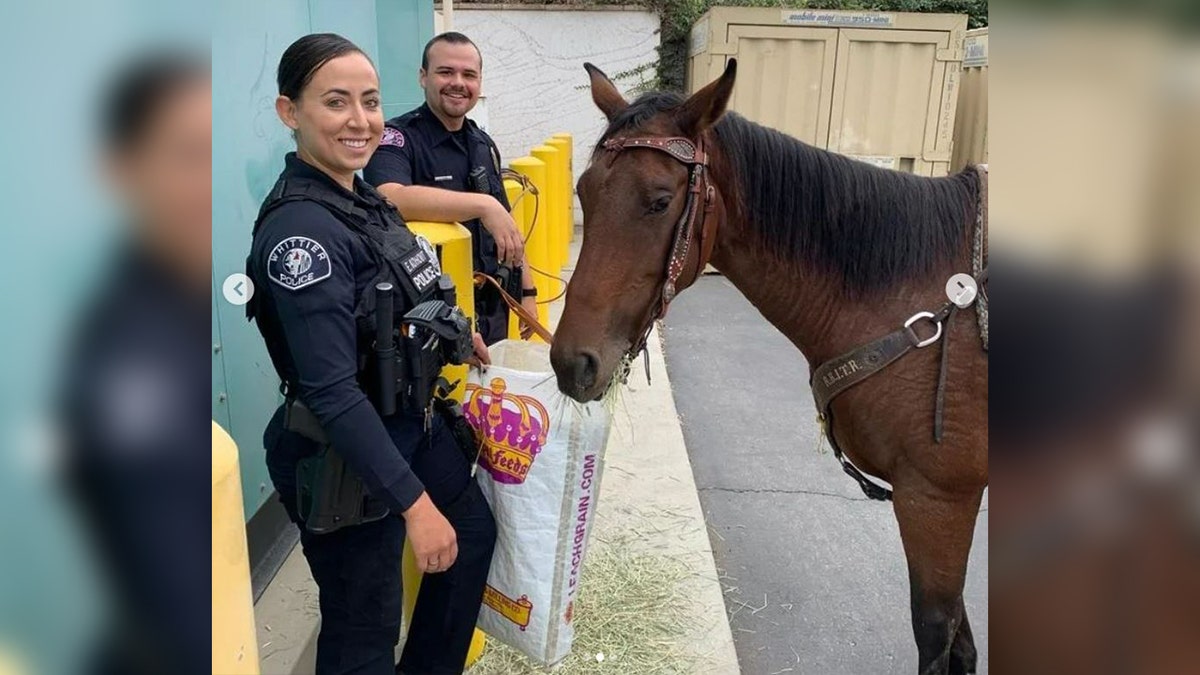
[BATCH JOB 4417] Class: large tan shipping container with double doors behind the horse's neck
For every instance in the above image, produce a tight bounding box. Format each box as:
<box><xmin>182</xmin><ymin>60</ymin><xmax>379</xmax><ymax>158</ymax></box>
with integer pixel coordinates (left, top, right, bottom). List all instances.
<box><xmin>688</xmin><ymin>7</ymin><xmax>967</xmax><ymax>175</ymax></box>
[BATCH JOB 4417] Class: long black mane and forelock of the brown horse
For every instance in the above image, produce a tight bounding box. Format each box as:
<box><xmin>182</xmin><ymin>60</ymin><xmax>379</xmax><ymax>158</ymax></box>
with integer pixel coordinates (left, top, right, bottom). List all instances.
<box><xmin>596</xmin><ymin>92</ymin><xmax>978</xmax><ymax>293</ymax></box>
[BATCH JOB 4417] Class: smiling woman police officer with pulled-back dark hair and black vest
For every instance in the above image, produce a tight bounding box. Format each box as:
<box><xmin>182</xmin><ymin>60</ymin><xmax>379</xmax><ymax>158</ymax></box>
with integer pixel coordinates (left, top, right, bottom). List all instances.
<box><xmin>247</xmin><ymin>34</ymin><xmax>496</xmax><ymax>675</ymax></box>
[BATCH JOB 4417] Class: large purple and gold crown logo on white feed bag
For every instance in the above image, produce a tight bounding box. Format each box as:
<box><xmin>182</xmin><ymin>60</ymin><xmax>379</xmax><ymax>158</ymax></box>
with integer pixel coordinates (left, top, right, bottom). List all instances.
<box><xmin>463</xmin><ymin>377</ymin><xmax>550</xmax><ymax>485</ymax></box>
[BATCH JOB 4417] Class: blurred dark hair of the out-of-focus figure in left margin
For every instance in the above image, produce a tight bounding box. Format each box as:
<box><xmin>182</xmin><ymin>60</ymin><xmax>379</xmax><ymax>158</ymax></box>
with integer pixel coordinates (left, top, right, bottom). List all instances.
<box><xmin>101</xmin><ymin>49</ymin><xmax>212</xmax><ymax>153</ymax></box>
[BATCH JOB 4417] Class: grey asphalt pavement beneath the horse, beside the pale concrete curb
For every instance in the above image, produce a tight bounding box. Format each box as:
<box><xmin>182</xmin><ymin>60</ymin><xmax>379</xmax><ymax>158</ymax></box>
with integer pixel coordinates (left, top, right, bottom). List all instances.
<box><xmin>664</xmin><ymin>276</ymin><xmax>988</xmax><ymax>675</ymax></box>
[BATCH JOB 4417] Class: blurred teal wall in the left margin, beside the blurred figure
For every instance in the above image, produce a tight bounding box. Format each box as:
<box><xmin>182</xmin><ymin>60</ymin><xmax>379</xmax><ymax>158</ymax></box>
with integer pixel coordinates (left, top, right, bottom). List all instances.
<box><xmin>0</xmin><ymin>0</ymin><xmax>211</xmax><ymax>674</ymax></box>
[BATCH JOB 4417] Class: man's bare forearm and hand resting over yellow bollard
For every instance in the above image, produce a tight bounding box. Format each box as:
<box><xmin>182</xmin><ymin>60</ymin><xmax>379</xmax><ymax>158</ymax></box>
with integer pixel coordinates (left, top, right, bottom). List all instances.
<box><xmin>377</xmin><ymin>183</ymin><xmax>524</xmax><ymax>263</ymax></box>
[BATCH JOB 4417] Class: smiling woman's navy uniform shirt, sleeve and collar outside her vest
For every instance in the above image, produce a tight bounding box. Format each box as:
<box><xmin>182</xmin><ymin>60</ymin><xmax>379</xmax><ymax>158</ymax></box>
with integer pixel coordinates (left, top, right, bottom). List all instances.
<box><xmin>247</xmin><ymin>153</ymin><xmax>425</xmax><ymax>513</ymax></box>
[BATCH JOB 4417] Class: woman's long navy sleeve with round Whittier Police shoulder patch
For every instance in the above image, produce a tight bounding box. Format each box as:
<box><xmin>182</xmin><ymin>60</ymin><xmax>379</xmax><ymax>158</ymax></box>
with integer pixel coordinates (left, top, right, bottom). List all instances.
<box><xmin>254</xmin><ymin>202</ymin><xmax>425</xmax><ymax>513</ymax></box>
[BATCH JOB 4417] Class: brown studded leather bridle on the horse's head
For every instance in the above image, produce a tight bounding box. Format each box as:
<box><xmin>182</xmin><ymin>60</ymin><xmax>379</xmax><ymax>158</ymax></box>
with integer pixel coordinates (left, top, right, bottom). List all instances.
<box><xmin>601</xmin><ymin>136</ymin><xmax>716</xmax><ymax>365</ymax></box>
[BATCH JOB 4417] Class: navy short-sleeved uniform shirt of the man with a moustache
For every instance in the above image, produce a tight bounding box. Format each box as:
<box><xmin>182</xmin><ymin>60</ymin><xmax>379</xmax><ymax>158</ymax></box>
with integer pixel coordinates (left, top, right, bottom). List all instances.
<box><xmin>362</xmin><ymin>103</ymin><xmax>510</xmax><ymax>274</ymax></box>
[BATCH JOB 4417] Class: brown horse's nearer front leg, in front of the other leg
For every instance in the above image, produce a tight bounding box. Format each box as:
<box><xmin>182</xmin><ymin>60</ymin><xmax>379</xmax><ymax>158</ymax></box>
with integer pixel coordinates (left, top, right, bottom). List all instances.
<box><xmin>894</xmin><ymin>479</ymin><xmax>983</xmax><ymax>675</ymax></box>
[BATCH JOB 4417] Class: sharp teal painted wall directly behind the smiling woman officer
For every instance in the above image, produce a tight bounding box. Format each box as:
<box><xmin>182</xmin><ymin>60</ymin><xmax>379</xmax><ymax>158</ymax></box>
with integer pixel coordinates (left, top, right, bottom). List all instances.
<box><xmin>212</xmin><ymin>0</ymin><xmax>433</xmax><ymax>520</ymax></box>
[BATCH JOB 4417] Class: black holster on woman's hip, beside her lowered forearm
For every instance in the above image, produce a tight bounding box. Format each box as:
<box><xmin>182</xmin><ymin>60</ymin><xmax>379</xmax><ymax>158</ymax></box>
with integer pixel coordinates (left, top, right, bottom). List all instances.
<box><xmin>283</xmin><ymin>400</ymin><xmax>389</xmax><ymax>534</ymax></box>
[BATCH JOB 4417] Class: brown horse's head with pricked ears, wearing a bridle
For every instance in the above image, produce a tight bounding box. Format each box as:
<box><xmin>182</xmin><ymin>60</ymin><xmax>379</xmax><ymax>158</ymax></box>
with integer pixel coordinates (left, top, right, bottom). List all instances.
<box><xmin>551</xmin><ymin>59</ymin><xmax>737</xmax><ymax>401</ymax></box>
